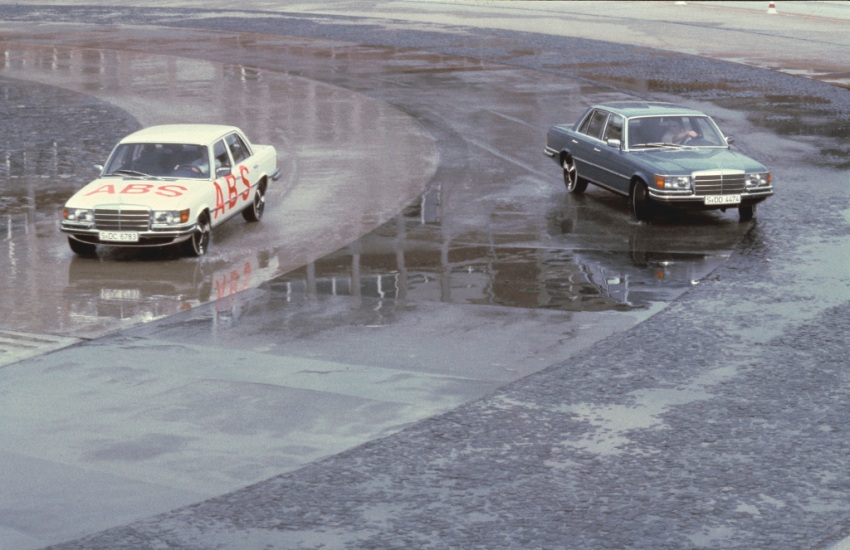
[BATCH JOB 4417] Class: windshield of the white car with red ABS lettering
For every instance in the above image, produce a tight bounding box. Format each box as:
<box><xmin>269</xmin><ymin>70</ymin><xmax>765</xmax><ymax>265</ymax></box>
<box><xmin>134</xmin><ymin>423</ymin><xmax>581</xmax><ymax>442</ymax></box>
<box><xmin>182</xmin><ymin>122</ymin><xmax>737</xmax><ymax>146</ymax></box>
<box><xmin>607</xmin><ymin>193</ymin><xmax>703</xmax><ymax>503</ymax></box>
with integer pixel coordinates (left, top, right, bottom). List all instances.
<box><xmin>103</xmin><ymin>143</ymin><xmax>210</xmax><ymax>179</ymax></box>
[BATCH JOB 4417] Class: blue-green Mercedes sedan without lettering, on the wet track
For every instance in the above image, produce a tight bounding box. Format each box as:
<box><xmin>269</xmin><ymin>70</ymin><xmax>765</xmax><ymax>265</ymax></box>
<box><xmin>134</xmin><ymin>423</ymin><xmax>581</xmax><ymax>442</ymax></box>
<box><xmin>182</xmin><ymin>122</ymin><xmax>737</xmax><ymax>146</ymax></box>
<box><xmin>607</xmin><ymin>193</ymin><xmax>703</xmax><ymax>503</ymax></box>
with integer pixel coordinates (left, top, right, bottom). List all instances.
<box><xmin>544</xmin><ymin>101</ymin><xmax>773</xmax><ymax>221</ymax></box>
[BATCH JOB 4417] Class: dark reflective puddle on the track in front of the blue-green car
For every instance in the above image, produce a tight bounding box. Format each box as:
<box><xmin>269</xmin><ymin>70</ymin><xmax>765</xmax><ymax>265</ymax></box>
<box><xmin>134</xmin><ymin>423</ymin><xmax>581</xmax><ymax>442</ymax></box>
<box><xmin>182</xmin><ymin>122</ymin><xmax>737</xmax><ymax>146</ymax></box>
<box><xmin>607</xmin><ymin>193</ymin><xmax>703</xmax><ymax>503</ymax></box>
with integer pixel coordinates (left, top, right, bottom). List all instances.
<box><xmin>268</xmin><ymin>203</ymin><xmax>743</xmax><ymax>311</ymax></box>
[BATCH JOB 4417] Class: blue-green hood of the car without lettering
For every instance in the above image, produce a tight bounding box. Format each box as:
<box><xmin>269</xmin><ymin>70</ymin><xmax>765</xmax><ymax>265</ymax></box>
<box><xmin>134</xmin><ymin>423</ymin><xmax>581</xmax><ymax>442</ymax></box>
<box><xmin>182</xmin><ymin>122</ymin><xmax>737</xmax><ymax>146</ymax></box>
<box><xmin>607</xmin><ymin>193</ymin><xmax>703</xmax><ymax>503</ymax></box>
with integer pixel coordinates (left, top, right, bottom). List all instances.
<box><xmin>633</xmin><ymin>148</ymin><xmax>767</xmax><ymax>174</ymax></box>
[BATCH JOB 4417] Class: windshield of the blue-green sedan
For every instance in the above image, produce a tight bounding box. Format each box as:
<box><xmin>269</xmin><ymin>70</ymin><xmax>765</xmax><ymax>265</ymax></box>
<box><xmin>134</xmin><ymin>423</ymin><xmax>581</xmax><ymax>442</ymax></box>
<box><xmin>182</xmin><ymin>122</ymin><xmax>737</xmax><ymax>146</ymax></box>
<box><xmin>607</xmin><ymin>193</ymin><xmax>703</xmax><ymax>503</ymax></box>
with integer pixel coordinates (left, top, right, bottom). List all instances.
<box><xmin>628</xmin><ymin>116</ymin><xmax>727</xmax><ymax>149</ymax></box>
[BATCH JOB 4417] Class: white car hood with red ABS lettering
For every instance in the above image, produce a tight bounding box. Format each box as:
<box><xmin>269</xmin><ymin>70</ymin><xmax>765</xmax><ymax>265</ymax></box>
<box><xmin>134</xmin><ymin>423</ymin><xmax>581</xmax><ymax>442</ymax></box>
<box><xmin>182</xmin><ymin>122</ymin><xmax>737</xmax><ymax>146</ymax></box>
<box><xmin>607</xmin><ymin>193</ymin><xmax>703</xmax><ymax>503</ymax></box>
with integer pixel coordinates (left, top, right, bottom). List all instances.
<box><xmin>66</xmin><ymin>177</ymin><xmax>210</xmax><ymax>210</ymax></box>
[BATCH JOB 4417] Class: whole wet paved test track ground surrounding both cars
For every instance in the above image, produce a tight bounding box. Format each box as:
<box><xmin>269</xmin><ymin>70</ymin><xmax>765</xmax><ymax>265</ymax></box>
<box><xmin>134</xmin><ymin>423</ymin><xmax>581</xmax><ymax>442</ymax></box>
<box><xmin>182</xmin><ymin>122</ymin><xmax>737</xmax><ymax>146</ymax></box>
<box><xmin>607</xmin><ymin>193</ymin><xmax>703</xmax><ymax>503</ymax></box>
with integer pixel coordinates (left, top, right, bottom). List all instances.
<box><xmin>0</xmin><ymin>1</ymin><xmax>850</xmax><ymax>548</ymax></box>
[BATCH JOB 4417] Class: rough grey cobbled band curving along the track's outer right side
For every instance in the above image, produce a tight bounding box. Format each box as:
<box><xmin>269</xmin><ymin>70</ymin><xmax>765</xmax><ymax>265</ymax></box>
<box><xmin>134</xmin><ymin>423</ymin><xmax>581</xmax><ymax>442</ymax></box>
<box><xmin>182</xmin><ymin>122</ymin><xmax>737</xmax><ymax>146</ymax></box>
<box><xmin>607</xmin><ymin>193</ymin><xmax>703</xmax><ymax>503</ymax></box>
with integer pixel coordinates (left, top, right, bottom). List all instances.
<box><xmin>0</xmin><ymin>1</ymin><xmax>850</xmax><ymax>548</ymax></box>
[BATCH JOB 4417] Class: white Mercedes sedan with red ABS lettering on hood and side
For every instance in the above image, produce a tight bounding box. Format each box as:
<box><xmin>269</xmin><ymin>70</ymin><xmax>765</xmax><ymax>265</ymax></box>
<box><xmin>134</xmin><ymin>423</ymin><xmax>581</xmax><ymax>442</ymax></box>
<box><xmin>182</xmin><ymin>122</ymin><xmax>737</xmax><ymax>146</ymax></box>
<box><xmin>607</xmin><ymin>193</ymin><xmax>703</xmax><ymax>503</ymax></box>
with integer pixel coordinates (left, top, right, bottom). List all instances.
<box><xmin>61</xmin><ymin>124</ymin><xmax>280</xmax><ymax>256</ymax></box>
